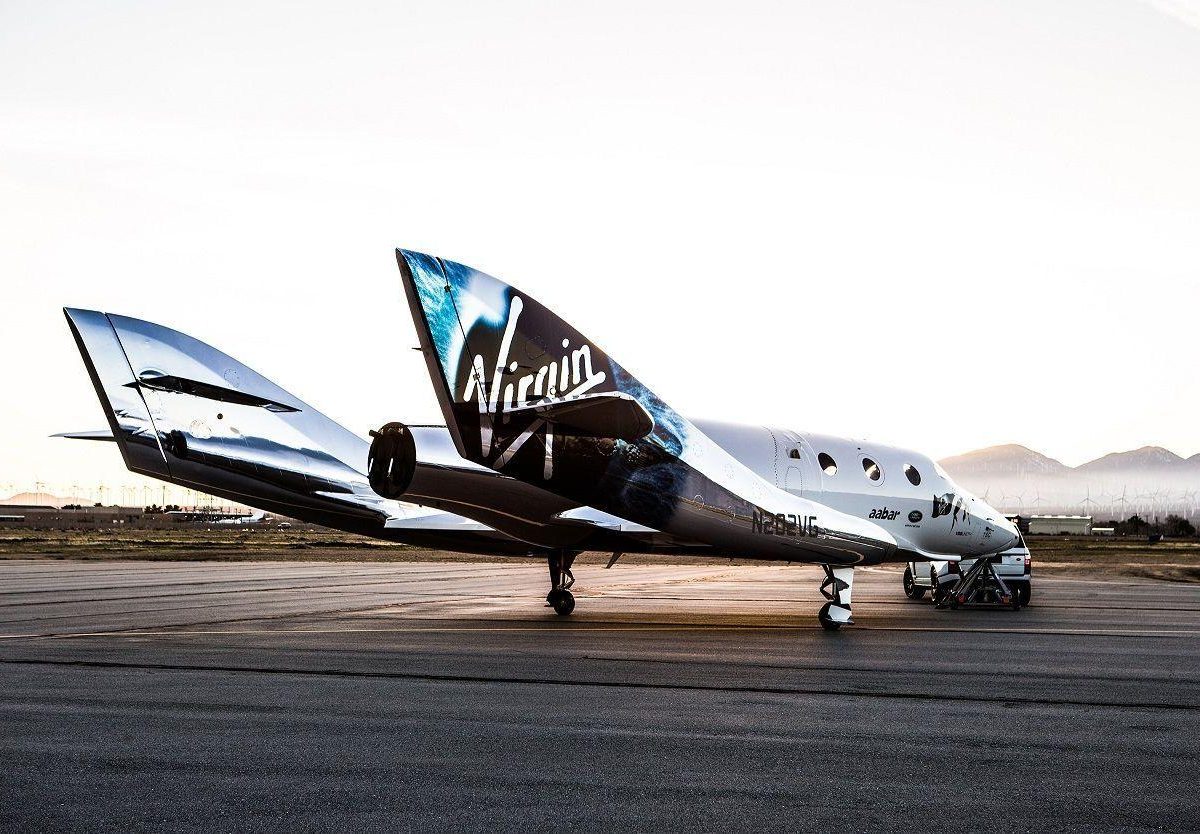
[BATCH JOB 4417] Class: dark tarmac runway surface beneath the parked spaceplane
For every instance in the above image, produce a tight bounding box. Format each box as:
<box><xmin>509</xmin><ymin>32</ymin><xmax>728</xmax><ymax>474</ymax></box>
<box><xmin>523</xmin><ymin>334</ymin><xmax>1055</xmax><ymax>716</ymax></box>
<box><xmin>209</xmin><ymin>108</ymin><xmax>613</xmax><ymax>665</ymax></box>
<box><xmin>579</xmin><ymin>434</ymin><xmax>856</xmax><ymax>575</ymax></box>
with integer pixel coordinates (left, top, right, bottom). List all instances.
<box><xmin>0</xmin><ymin>562</ymin><xmax>1200</xmax><ymax>830</ymax></box>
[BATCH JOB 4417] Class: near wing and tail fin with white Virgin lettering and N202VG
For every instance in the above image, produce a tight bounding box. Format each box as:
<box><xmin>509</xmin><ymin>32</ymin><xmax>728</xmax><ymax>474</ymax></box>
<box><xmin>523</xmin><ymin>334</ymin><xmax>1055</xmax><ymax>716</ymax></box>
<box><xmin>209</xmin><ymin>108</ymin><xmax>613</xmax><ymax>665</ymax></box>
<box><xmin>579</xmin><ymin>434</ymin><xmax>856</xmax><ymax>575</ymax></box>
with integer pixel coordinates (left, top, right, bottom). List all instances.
<box><xmin>396</xmin><ymin>244</ymin><xmax>895</xmax><ymax>565</ymax></box>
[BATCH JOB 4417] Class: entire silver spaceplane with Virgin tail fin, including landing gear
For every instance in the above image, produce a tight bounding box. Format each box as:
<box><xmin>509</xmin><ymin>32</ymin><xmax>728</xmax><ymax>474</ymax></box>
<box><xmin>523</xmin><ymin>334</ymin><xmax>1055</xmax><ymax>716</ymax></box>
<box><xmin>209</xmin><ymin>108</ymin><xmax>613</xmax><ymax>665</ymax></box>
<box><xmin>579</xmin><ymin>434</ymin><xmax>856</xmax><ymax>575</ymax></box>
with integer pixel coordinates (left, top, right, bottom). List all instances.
<box><xmin>61</xmin><ymin>250</ymin><xmax>1018</xmax><ymax>630</ymax></box>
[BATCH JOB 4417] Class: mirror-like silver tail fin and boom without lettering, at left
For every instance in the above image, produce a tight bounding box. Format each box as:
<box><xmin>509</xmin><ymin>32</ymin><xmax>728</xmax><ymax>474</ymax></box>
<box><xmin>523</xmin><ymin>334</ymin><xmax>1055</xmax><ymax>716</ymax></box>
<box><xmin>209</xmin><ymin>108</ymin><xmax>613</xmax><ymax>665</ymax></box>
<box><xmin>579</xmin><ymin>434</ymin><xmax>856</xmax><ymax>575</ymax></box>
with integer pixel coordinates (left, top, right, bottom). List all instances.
<box><xmin>65</xmin><ymin>310</ymin><xmax>528</xmax><ymax>553</ymax></box>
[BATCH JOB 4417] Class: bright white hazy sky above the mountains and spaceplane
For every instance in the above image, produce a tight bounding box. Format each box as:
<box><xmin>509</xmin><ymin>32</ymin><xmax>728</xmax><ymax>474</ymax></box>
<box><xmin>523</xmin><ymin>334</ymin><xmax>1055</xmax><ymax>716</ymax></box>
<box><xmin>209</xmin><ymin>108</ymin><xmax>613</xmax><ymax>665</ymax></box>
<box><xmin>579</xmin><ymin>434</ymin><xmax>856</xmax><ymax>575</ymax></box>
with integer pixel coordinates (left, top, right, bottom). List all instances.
<box><xmin>0</xmin><ymin>0</ymin><xmax>1200</xmax><ymax>490</ymax></box>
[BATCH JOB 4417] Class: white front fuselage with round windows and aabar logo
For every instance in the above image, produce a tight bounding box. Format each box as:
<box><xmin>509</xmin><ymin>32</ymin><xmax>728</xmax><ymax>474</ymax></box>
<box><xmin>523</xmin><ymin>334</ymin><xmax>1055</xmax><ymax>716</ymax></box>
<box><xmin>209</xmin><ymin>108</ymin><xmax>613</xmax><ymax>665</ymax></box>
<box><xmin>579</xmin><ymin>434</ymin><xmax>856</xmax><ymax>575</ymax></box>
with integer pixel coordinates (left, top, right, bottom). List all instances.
<box><xmin>692</xmin><ymin>420</ymin><xmax>1016</xmax><ymax>559</ymax></box>
